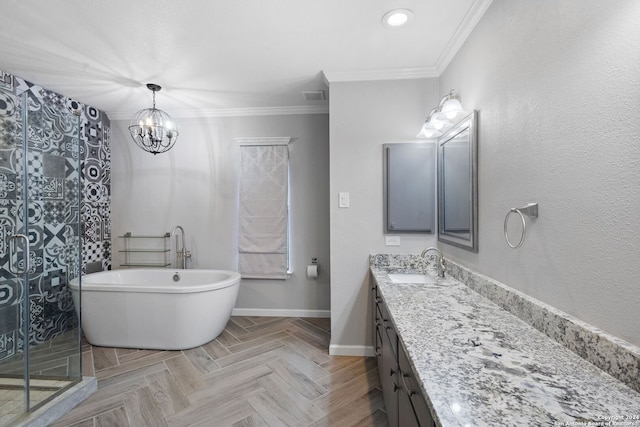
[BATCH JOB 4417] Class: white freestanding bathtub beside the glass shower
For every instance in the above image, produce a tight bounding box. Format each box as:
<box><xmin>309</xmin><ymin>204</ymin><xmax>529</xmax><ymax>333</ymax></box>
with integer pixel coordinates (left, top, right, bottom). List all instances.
<box><xmin>69</xmin><ymin>269</ymin><xmax>240</xmax><ymax>350</ymax></box>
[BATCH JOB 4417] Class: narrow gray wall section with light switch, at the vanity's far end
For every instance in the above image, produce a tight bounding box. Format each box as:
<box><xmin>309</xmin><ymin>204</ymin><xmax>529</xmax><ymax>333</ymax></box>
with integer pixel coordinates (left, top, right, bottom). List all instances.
<box><xmin>329</xmin><ymin>79</ymin><xmax>440</xmax><ymax>355</ymax></box>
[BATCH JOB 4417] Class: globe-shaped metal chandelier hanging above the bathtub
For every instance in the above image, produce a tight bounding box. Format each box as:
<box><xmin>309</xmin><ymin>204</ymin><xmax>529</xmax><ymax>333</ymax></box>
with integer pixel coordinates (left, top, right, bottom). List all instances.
<box><xmin>129</xmin><ymin>83</ymin><xmax>178</xmax><ymax>154</ymax></box>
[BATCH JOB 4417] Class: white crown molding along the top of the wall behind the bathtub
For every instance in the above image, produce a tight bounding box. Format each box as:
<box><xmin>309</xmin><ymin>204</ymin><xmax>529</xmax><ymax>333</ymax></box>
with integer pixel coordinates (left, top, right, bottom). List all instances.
<box><xmin>107</xmin><ymin>104</ymin><xmax>329</xmax><ymax>120</ymax></box>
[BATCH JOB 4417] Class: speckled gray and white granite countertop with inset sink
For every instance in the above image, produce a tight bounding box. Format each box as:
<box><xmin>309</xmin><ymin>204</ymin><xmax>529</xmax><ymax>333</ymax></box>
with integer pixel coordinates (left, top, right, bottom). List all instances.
<box><xmin>371</xmin><ymin>266</ymin><xmax>640</xmax><ymax>427</ymax></box>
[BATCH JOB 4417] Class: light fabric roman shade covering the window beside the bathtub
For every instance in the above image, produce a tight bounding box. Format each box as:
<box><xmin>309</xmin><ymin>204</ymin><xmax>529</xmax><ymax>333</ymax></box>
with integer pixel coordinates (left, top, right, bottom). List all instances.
<box><xmin>238</xmin><ymin>145</ymin><xmax>289</xmax><ymax>279</ymax></box>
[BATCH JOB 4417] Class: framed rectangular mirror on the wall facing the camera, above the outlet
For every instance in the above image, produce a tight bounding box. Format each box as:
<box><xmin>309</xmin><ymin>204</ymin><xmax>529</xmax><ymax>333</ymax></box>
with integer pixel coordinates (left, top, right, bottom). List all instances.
<box><xmin>383</xmin><ymin>142</ymin><xmax>436</xmax><ymax>234</ymax></box>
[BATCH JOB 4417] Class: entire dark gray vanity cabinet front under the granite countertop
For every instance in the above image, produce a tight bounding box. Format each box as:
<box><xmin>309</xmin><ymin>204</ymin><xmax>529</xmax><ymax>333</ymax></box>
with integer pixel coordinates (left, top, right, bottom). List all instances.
<box><xmin>372</xmin><ymin>285</ymin><xmax>435</xmax><ymax>427</ymax></box>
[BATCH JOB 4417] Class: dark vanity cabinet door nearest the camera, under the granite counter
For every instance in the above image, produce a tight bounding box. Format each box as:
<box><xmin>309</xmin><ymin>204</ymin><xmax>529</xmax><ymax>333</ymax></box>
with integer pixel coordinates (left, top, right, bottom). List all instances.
<box><xmin>398</xmin><ymin>346</ymin><xmax>435</xmax><ymax>427</ymax></box>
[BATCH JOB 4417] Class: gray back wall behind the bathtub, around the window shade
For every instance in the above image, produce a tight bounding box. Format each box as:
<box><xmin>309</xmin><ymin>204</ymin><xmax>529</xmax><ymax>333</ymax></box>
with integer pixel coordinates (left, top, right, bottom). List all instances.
<box><xmin>112</xmin><ymin>112</ymin><xmax>330</xmax><ymax>315</ymax></box>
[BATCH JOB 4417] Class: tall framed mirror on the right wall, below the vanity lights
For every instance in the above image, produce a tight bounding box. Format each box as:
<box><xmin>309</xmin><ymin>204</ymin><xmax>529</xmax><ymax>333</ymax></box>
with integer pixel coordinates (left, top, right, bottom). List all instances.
<box><xmin>438</xmin><ymin>111</ymin><xmax>478</xmax><ymax>252</ymax></box>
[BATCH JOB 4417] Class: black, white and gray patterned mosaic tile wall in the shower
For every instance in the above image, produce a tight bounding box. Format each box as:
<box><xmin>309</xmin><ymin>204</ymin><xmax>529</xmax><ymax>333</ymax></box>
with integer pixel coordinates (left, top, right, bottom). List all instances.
<box><xmin>0</xmin><ymin>71</ymin><xmax>111</xmax><ymax>360</ymax></box>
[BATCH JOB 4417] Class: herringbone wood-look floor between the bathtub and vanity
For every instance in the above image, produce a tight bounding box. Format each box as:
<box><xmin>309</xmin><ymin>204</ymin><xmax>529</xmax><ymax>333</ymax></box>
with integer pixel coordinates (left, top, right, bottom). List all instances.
<box><xmin>54</xmin><ymin>317</ymin><xmax>387</xmax><ymax>427</ymax></box>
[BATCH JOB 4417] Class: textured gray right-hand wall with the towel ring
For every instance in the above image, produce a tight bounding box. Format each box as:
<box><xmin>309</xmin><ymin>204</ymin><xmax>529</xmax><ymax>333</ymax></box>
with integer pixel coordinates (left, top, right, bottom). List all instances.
<box><xmin>442</xmin><ymin>0</ymin><xmax>640</xmax><ymax>345</ymax></box>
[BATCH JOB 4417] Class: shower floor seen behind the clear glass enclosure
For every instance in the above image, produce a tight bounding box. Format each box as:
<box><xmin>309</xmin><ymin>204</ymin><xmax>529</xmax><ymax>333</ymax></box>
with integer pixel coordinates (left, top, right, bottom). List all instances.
<box><xmin>0</xmin><ymin>329</ymin><xmax>81</xmax><ymax>425</ymax></box>
